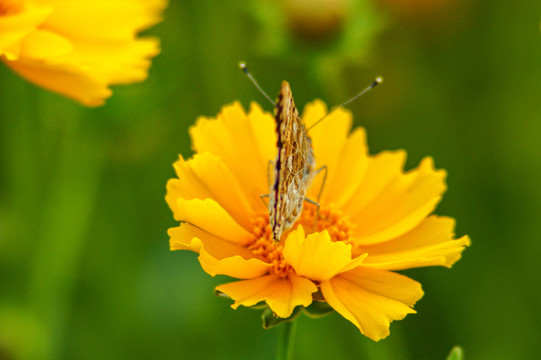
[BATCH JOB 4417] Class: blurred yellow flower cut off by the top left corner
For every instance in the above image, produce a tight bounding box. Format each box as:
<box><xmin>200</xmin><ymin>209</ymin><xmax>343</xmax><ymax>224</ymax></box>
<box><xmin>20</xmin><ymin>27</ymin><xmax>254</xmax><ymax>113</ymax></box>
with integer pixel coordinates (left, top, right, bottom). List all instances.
<box><xmin>0</xmin><ymin>0</ymin><xmax>166</xmax><ymax>106</ymax></box>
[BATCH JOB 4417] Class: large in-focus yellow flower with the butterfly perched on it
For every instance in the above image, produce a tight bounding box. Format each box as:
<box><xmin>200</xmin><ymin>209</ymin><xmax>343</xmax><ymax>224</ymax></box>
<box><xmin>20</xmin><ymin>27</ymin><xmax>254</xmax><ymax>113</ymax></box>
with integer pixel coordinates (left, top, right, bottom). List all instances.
<box><xmin>166</xmin><ymin>101</ymin><xmax>469</xmax><ymax>340</ymax></box>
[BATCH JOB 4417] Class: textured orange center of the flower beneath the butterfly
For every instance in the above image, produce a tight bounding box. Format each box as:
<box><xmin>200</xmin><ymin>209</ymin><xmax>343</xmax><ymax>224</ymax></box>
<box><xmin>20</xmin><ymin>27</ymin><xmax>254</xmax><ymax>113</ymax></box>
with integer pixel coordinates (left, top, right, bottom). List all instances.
<box><xmin>245</xmin><ymin>203</ymin><xmax>353</xmax><ymax>277</ymax></box>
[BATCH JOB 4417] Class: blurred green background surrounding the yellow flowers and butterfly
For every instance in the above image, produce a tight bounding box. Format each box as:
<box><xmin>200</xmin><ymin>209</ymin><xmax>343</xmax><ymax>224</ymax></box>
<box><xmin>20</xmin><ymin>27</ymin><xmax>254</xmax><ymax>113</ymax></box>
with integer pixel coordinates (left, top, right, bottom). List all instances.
<box><xmin>0</xmin><ymin>0</ymin><xmax>541</xmax><ymax>359</ymax></box>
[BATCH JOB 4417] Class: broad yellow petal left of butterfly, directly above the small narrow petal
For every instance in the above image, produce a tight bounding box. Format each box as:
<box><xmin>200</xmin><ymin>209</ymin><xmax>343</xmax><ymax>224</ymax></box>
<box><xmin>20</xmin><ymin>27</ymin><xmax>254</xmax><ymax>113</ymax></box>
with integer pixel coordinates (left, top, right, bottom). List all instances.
<box><xmin>166</xmin><ymin>153</ymin><xmax>254</xmax><ymax>231</ymax></box>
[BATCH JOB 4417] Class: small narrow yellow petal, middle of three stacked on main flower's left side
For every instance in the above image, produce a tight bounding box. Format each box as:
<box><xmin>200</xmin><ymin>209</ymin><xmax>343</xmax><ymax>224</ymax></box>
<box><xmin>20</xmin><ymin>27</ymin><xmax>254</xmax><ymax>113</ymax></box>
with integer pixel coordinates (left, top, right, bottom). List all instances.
<box><xmin>174</xmin><ymin>198</ymin><xmax>252</xmax><ymax>244</ymax></box>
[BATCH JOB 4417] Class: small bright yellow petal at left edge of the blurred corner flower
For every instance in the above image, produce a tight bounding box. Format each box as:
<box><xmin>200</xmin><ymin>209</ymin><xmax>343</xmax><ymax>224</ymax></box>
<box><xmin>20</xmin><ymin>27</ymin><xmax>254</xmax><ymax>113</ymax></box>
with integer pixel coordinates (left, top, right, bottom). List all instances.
<box><xmin>0</xmin><ymin>3</ymin><xmax>51</xmax><ymax>55</ymax></box>
